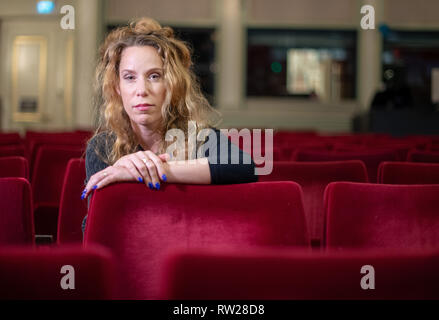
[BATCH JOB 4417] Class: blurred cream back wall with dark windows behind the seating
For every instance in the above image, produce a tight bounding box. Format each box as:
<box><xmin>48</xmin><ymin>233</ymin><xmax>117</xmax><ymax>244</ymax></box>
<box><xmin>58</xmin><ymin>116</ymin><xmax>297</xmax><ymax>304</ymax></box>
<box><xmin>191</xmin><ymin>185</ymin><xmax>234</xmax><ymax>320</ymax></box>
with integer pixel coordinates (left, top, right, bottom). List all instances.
<box><xmin>0</xmin><ymin>0</ymin><xmax>439</xmax><ymax>132</ymax></box>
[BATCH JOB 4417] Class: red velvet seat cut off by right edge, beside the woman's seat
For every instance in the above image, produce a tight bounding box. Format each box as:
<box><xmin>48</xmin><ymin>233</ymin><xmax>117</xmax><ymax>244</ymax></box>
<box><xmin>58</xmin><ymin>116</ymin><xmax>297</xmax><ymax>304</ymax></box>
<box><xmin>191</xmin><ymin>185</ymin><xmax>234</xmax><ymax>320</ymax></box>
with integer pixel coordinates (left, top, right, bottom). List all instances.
<box><xmin>325</xmin><ymin>182</ymin><xmax>439</xmax><ymax>248</ymax></box>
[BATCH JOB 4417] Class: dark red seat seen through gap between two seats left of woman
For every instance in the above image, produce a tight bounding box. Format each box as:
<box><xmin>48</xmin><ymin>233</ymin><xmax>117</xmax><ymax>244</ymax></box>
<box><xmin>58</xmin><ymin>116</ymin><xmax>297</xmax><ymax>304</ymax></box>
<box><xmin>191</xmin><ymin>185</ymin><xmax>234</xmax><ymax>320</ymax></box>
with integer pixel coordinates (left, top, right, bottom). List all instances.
<box><xmin>32</xmin><ymin>145</ymin><xmax>83</xmax><ymax>239</ymax></box>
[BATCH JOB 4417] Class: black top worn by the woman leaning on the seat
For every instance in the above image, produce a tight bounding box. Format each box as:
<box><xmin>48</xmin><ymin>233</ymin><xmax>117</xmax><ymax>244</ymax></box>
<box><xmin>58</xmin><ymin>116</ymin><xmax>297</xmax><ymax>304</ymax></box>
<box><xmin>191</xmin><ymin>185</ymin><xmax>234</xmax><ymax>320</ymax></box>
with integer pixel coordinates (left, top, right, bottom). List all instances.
<box><xmin>85</xmin><ymin>129</ymin><xmax>258</xmax><ymax>184</ymax></box>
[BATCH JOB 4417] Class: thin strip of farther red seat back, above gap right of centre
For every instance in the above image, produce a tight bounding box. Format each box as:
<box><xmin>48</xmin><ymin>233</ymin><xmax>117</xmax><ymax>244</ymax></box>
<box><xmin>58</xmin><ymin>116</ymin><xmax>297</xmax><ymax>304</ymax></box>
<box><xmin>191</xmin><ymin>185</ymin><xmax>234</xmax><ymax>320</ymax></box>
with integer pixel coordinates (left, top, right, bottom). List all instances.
<box><xmin>293</xmin><ymin>149</ymin><xmax>398</xmax><ymax>182</ymax></box>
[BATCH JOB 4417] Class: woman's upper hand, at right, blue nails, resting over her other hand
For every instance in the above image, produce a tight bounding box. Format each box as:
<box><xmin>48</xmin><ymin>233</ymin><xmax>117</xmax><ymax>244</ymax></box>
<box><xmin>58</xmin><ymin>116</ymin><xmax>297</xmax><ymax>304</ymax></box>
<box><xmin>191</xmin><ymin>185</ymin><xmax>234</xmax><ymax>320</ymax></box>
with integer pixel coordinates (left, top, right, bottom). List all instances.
<box><xmin>113</xmin><ymin>150</ymin><xmax>169</xmax><ymax>190</ymax></box>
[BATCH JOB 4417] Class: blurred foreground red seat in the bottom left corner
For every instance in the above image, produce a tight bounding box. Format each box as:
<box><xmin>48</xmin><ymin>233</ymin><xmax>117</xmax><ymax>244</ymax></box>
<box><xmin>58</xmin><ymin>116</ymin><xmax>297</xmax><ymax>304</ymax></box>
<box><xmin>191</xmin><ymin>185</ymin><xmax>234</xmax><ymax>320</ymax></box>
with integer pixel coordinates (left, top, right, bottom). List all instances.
<box><xmin>0</xmin><ymin>246</ymin><xmax>116</xmax><ymax>300</ymax></box>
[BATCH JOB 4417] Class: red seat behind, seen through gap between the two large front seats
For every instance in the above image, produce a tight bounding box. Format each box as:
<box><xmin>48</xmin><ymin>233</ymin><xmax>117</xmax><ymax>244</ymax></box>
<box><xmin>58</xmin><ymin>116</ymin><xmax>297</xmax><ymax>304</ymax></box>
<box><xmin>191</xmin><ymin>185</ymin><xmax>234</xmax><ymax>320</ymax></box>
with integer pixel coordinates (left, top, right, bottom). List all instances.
<box><xmin>259</xmin><ymin>160</ymin><xmax>367</xmax><ymax>246</ymax></box>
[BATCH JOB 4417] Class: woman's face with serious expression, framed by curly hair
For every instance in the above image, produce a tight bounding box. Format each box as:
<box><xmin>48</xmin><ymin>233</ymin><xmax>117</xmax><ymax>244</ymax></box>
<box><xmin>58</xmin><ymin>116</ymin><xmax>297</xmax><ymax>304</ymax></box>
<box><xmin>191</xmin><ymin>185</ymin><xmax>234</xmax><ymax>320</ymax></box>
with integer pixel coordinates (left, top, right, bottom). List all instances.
<box><xmin>118</xmin><ymin>46</ymin><xmax>166</xmax><ymax>129</ymax></box>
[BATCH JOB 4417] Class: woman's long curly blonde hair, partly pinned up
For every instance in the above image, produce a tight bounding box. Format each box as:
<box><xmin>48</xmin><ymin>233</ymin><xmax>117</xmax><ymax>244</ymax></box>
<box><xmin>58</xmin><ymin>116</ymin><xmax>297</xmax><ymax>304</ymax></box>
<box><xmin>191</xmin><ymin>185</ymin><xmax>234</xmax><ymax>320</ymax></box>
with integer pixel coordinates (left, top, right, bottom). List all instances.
<box><xmin>92</xmin><ymin>18</ymin><xmax>218</xmax><ymax>164</ymax></box>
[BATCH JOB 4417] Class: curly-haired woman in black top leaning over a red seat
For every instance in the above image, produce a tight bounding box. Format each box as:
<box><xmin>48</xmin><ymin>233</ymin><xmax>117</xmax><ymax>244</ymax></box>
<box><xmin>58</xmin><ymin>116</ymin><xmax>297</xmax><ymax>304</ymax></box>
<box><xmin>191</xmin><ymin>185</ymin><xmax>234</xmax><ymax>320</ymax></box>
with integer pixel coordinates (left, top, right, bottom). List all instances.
<box><xmin>81</xmin><ymin>18</ymin><xmax>257</xmax><ymax>199</ymax></box>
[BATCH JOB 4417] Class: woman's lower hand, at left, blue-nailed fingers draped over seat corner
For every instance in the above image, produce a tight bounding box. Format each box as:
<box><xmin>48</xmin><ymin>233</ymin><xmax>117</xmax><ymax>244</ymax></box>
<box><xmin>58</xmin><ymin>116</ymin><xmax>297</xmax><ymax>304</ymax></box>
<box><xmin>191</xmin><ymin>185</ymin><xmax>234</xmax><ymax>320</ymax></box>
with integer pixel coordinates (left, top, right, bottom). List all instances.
<box><xmin>81</xmin><ymin>166</ymin><xmax>133</xmax><ymax>199</ymax></box>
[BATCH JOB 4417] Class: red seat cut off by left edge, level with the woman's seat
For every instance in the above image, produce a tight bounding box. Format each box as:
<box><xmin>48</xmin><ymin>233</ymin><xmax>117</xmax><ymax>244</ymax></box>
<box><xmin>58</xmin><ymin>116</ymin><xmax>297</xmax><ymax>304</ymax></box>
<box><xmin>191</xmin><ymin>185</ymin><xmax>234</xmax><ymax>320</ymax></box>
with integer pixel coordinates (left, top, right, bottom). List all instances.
<box><xmin>0</xmin><ymin>178</ymin><xmax>35</xmax><ymax>246</ymax></box>
